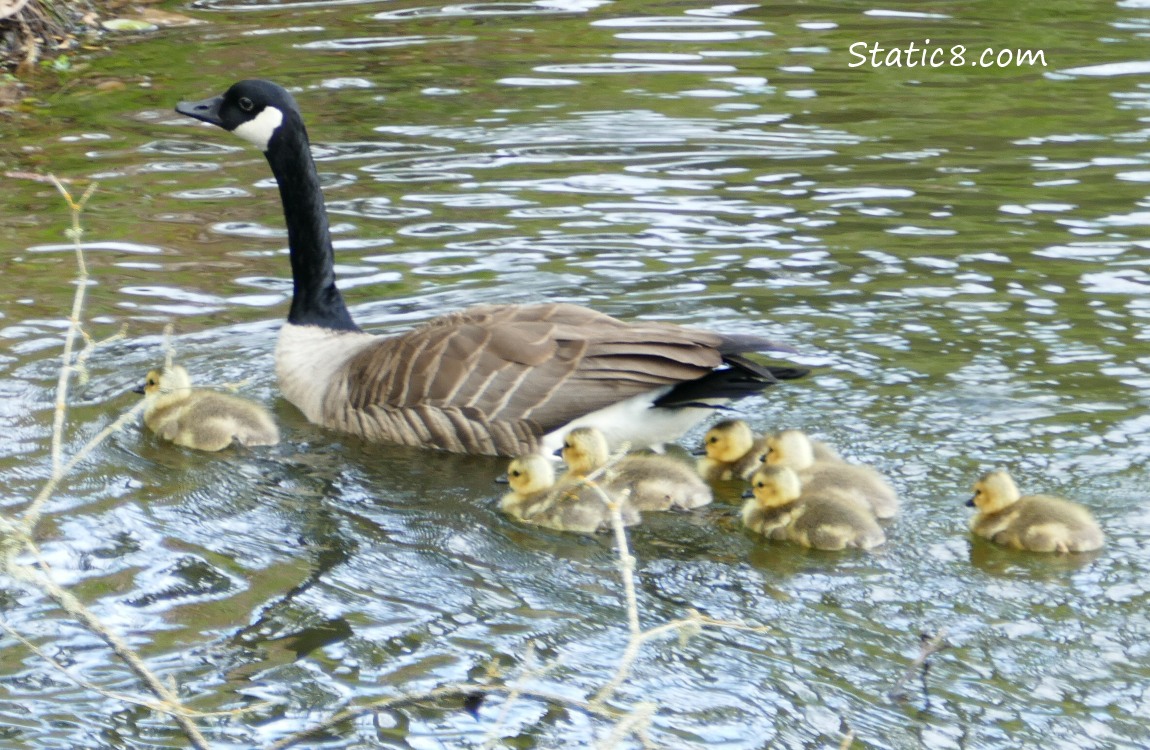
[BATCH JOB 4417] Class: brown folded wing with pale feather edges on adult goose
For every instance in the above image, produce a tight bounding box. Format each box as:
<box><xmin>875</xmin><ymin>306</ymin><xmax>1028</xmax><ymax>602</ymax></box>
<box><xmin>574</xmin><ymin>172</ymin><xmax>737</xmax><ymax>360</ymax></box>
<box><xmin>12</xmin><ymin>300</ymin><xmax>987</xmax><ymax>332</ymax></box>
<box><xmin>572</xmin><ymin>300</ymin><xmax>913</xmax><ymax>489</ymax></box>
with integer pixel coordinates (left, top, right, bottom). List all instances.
<box><xmin>335</xmin><ymin>304</ymin><xmax>722</xmax><ymax>436</ymax></box>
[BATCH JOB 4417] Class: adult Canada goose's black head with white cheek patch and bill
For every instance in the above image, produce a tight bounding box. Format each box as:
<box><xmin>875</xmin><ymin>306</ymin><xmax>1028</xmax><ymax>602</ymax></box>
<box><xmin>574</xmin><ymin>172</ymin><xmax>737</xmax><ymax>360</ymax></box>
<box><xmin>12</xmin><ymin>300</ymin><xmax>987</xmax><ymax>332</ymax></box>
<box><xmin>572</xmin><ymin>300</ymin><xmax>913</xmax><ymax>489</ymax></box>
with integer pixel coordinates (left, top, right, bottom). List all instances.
<box><xmin>176</xmin><ymin>79</ymin><xmax>302</xmax><ymax>152</ymax></box>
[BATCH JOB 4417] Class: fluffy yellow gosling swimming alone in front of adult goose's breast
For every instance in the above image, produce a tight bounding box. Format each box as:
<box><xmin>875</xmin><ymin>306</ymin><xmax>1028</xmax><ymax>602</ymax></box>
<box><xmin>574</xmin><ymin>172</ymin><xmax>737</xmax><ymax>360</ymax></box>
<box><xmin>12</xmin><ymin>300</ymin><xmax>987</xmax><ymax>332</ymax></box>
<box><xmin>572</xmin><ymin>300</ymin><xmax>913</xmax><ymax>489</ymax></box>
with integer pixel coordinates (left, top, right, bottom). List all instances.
<box><xmin>136</xmin><ymin>365</ymin><xmax>279</xmax><ymax>451</ymax></box>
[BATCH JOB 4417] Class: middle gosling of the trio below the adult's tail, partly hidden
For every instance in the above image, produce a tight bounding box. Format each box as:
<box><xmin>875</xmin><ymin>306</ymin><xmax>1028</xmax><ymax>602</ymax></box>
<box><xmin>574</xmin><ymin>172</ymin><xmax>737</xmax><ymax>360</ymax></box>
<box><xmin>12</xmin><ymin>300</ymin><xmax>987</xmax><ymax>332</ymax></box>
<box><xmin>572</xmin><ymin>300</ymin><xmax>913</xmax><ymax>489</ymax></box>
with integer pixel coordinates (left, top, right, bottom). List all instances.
<box><xmin>764</xmin><ymin>430</ymin><xmax>898</xmax><ymax>519</ymax></box>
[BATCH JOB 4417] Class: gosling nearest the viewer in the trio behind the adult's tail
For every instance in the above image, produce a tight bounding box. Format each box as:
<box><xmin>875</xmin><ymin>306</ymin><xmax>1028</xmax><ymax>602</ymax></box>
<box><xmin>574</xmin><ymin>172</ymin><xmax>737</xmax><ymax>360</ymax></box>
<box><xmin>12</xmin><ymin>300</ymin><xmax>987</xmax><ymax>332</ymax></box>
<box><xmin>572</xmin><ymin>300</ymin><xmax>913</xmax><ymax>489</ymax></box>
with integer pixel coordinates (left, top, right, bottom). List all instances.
<box><xmin>743</xmin><ymin>466</ymin><xmax>887</xmax><ymax>550</ymax></box>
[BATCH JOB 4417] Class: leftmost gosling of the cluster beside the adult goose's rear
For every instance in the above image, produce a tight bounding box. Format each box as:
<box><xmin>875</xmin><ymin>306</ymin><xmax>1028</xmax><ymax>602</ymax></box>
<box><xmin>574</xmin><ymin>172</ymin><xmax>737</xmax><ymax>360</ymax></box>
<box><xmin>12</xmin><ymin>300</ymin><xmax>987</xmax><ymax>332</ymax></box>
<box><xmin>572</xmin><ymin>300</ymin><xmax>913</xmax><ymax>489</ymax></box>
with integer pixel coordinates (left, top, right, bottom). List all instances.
<box><xmin>499</xmin><ymin>453</ymin><xmax>639</xmax><ymax>534</ymax></box>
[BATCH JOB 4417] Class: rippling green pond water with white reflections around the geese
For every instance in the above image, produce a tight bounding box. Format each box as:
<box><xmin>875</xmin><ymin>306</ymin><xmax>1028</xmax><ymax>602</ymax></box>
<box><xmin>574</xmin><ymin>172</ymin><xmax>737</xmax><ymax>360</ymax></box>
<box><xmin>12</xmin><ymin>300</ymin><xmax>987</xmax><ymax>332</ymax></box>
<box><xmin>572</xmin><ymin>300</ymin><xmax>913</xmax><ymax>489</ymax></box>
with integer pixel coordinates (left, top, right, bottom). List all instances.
<box><xmin>0</xmin><ymin>0</ymin><xmax>1150</xmax><ymax>750</ymax></box>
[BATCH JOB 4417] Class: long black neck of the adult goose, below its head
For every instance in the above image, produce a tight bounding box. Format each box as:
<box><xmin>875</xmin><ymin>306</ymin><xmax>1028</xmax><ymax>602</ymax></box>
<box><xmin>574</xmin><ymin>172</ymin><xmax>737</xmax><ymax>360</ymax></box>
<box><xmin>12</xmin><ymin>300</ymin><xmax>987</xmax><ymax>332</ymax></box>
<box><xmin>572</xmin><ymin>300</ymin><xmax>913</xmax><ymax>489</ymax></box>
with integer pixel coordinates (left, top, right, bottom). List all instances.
<box><xmin>265</xmin><ymin>113</ymin><xmax>360</xmax><ymax>331</ymax></box>
